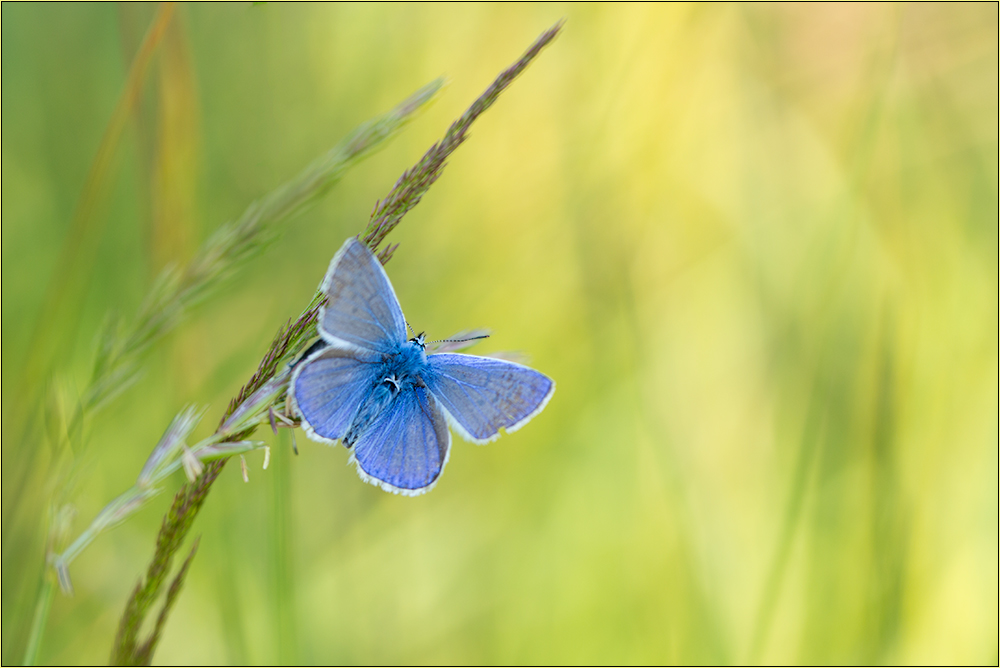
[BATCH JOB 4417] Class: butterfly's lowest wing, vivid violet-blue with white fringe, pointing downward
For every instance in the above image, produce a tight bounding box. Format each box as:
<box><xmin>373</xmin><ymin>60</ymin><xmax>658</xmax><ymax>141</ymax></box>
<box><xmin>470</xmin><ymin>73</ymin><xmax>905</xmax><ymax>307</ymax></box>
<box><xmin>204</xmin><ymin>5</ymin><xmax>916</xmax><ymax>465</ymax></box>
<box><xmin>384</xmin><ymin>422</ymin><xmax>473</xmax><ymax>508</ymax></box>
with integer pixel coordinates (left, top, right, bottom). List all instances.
<box><xmin>353</xmin><ymin>386</ymin><xmax>451</xmax><ymax>496</ymax></box>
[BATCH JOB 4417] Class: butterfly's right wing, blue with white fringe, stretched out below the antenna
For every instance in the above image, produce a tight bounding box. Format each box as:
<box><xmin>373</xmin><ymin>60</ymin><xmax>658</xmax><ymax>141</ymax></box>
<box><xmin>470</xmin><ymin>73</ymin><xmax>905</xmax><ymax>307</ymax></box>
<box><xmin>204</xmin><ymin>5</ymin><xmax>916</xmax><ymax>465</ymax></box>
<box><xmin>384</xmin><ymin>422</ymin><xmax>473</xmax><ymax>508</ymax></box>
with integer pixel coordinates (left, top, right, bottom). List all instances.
<box><xmin>424</xmin><ymin>353</ymin><xmax>556</xmax><ymax>443</ymax></box>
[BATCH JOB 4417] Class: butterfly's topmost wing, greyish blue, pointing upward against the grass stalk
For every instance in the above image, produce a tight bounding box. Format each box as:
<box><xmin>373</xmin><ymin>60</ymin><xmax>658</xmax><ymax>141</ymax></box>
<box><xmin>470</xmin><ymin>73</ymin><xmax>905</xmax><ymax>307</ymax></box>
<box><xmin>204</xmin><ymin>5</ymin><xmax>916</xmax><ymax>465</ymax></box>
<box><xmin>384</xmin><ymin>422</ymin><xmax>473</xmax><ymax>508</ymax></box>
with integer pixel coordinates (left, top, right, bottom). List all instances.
<box><xmin>319</xmin><ymin>237</ymin><xmax>406</xmax><ymax>352</ymax></box>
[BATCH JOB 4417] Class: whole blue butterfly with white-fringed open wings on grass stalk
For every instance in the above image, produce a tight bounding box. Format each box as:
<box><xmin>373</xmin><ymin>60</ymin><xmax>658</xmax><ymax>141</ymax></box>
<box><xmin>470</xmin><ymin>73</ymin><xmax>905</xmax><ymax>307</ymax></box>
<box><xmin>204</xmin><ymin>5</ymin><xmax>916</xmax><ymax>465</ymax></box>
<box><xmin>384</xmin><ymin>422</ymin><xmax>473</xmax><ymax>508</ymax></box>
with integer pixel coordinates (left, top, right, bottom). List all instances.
<box><xmin>290</xmin><ymin>237</ymin><xmax>556</xmax><ymax>496</ymax></box>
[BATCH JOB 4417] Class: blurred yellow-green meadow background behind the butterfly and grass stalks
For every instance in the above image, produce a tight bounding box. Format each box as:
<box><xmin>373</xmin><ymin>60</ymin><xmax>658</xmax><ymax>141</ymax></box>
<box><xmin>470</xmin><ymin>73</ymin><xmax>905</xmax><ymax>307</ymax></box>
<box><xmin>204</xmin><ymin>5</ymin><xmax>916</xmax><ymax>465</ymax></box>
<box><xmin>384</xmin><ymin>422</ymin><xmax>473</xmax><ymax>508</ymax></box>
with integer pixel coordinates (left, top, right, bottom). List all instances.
<box><xmin>2</xmin><ymin>3</ymin><xmax>998</xmax><ymax>664</ymax></box>
